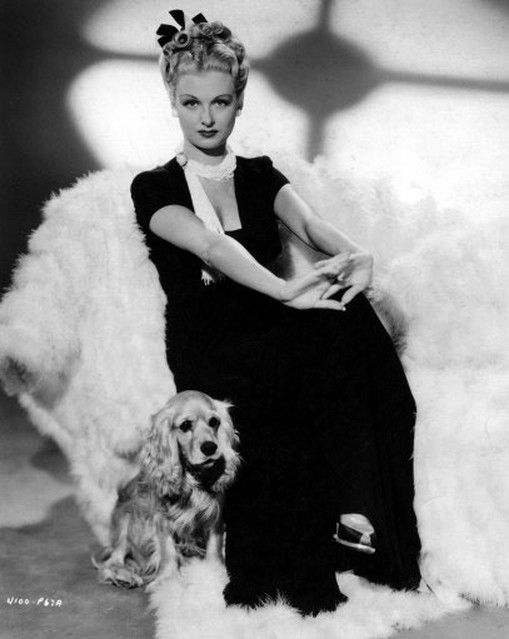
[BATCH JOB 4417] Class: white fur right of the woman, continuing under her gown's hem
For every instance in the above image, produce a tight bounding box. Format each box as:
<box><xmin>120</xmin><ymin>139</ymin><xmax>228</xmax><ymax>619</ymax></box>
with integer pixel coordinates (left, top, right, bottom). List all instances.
<box><xmin>147</xmin><ymin>156</ymin><xmax>509</xmax><ymax>639</ymax></box>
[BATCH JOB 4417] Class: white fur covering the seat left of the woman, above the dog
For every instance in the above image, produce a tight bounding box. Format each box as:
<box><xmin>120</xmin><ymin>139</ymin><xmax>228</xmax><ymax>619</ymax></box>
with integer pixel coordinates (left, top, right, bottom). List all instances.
<box><xmin>0</xmin><ymin>170</ymin><xmax>175</xmax><ymax>545</ymax></box>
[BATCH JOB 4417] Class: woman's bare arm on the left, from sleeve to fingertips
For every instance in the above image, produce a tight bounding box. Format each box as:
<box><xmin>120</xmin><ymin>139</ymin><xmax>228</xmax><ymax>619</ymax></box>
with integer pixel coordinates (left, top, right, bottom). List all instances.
<box><xmin>150</xmin><ymin>204</ymin><xmax>341</xmax><ymax>310</ymax></box>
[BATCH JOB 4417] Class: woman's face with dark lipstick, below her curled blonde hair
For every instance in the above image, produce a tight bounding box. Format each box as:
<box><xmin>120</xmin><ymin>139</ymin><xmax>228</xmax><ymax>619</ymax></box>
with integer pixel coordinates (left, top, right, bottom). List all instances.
<box><xmin>172</xmin><ymin>70</ymin><xmax>242</xmax><ymax>159</ymax></box>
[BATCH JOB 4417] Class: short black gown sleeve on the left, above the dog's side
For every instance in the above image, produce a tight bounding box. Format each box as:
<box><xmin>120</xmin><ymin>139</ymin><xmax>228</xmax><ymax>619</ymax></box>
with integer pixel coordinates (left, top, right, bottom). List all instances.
<box><xmin>131</xmin><ymin>168</ymin><xmax>180</xmax><ymax>234</ymax></box>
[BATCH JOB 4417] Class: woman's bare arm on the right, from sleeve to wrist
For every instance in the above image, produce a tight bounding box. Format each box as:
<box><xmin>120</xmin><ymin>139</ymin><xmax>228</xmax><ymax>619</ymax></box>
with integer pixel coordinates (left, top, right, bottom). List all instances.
<box><xmin>274</xmin><ymin>184</ymin><xmax>364</xmax><ymax>256</ymax></box>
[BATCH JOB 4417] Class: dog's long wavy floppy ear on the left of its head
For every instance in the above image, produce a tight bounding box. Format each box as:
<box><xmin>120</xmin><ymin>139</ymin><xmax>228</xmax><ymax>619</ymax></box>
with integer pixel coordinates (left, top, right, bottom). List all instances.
<box><xmin>140</xmin><ymin>403</ymin><xmax>182</xmax><ymax>497</ymax></box>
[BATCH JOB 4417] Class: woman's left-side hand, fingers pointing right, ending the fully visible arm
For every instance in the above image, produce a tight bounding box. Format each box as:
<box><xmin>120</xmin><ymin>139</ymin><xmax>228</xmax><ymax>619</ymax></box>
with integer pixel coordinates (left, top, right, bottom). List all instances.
<box><xmin>280</xmin><ymin>257</ymin><xmax>347</xmax><ymax>311</ymax></box>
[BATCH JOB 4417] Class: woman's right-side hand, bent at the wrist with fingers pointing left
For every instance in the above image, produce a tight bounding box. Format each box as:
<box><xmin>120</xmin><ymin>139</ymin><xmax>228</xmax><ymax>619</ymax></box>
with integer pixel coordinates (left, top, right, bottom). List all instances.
<box><xmin>314</xmin><ymin>252</ymin><xmax>373</xmax><ymax>310</ymax></box>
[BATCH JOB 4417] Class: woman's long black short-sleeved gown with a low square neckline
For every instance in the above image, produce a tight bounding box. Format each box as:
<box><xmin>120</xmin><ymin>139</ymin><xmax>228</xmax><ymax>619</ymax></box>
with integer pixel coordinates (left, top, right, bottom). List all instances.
<box><xmin>131</xmin><ymin>156</ymin><xmax>420</xmax><ymax>614</ymax></box>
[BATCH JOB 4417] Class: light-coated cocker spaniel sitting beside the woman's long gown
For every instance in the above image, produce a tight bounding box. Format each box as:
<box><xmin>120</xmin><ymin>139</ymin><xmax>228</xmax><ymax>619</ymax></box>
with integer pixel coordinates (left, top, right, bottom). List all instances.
<box><xmin>92</xmin><ymin>391</ymin><xmax>240</xmax><ymax>588</ymax></box>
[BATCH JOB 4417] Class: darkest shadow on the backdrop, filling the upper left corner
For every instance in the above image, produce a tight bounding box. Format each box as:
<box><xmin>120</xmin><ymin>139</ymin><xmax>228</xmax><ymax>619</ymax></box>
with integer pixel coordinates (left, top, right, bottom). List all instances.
<box><xmin>0</xmin><ymin>0</ymin><xmax>105</xmax><ymax>290</ymax></box>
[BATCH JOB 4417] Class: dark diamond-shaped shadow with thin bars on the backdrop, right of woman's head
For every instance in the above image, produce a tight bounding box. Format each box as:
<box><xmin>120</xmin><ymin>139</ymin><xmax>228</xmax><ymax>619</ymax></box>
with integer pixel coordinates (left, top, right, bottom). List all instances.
<box><xmin>252</xmin><ymin>0</ymin><xmax>509</xmax><ymax>160</ymax></box>
